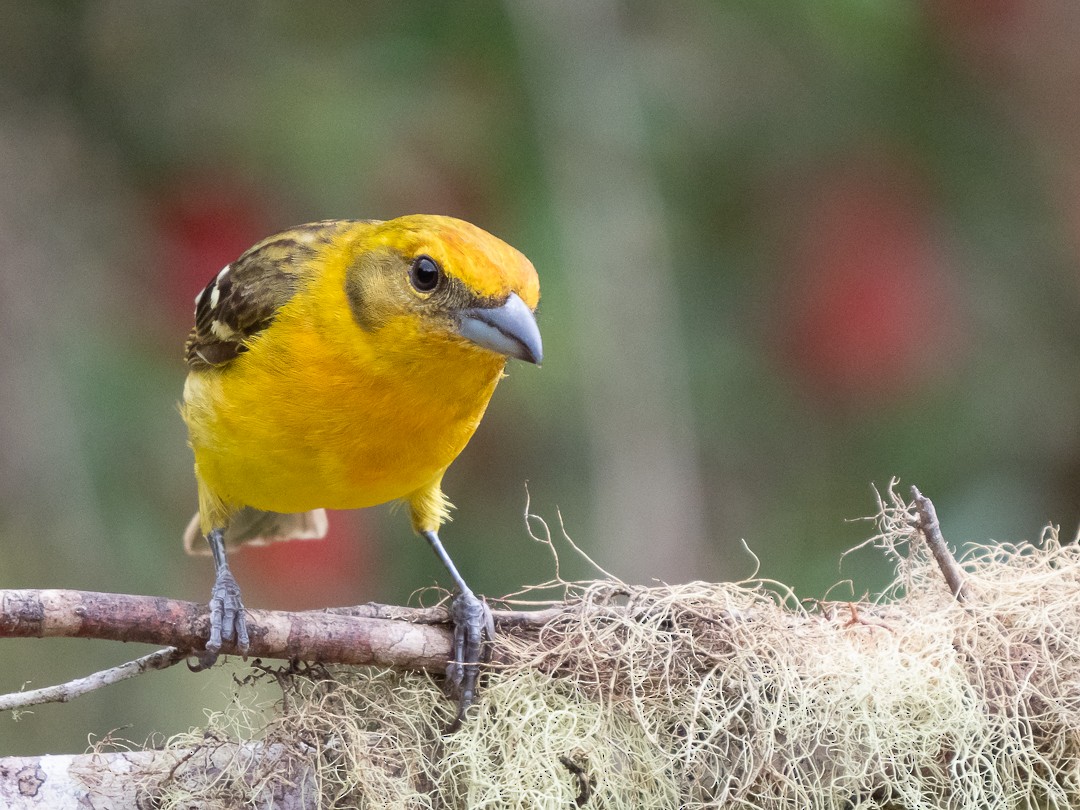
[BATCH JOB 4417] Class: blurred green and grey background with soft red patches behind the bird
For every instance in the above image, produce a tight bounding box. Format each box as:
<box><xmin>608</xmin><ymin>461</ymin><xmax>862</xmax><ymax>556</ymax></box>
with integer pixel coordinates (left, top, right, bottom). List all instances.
<box><xmin>0</xmin><ymin>0</ymin><xmax>1080</xmax><ymax>755</ymax></box>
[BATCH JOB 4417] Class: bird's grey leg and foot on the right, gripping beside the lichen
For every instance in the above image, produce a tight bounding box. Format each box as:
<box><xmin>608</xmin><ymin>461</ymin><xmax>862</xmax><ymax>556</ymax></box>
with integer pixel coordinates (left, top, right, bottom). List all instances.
<box><xmin>420</xmin><ymin>530</ymin><xmax>495</xmax><ymax>731</ymax></box>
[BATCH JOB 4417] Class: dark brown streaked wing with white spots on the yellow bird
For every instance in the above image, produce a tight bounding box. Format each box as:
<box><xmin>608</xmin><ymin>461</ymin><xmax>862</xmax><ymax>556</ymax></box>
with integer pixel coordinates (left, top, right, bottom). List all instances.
<box><xmin>184</xmin><ymin>220</ymin><xmax>354</xmax><ymax>369</ymax></box>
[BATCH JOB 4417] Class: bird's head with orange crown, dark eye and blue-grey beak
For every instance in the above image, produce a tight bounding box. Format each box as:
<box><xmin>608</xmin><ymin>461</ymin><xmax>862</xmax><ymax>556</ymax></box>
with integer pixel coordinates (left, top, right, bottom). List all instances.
<box><xmin>346</xmin><ymin>214</ymin><xmax>543</xmax><ymax>364</ymax></box>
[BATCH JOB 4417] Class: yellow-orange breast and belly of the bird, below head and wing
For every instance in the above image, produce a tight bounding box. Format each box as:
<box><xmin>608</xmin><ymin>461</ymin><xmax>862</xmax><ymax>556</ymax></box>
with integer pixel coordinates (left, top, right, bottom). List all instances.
<box><xmin>184</xmin><ymin>315</ymin><xmax>503</xmax><ymax>512</ymax></box>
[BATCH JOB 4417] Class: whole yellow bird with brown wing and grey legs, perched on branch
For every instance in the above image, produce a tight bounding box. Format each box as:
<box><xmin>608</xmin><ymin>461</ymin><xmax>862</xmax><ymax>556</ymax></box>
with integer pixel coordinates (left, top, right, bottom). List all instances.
<box><xmin>180</xmin><ymin>215</ymin><xmax>542</xmax><ymax>711</ymax></box>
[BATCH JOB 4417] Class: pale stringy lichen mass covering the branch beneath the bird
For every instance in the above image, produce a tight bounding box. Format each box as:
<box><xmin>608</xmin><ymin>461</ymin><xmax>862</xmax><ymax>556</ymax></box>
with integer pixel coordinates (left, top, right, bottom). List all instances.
<box><xmin>0</xmin><ymin>489</ymin><xmax>1080</xmax><ymax>810</ymax></box>
